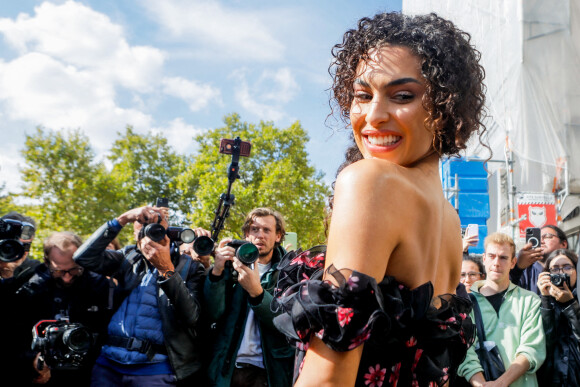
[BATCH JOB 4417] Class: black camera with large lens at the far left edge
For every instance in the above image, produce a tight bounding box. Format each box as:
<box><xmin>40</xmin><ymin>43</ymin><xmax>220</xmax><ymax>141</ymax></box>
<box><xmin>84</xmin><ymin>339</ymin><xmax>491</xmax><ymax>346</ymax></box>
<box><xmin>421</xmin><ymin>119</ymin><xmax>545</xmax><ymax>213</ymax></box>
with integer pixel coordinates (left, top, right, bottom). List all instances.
<box><xmin>0</xmin><ymin>219</ymin><xmax>35</xmax><ymax>262</ymax></box>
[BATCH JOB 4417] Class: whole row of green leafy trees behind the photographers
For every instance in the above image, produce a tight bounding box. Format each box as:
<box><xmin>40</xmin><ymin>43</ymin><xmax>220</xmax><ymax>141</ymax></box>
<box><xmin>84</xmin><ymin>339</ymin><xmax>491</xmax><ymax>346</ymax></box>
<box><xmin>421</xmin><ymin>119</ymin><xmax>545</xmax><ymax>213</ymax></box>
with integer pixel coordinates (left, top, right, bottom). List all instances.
<box><xmin>7</xmin><ymin>114</ymin><xmax>328</xmax><ymax>255</ymax></box>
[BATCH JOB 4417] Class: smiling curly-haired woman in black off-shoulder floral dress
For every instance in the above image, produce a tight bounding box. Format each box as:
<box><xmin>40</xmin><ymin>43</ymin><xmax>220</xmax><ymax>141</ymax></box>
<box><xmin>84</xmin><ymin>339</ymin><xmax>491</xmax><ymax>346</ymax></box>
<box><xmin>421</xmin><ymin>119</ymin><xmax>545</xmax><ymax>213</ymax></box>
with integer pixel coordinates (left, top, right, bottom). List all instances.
<box><xmin>275</xmin><ymin>13</ymin><xmax>485</xmax><ymax>386</ymax></box>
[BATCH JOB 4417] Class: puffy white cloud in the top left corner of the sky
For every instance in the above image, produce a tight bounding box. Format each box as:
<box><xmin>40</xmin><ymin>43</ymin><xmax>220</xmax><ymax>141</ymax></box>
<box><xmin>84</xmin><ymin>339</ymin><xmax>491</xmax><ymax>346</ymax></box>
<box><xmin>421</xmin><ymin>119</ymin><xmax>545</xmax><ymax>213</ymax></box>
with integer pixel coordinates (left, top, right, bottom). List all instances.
<box><xmin>0</xmin><ymin>1</ymin><xmax>165</xmax><ymax>92</ymax></box>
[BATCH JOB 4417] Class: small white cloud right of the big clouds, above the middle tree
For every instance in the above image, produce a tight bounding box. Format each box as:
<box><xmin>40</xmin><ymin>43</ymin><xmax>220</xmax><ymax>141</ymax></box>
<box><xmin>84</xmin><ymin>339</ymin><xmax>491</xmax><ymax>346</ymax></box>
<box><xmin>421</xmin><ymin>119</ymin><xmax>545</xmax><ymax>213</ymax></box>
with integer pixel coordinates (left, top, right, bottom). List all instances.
<box><xmin>163</xmin><ymin>77</ymin><xmax>221</xmax><ymax>112</ymax></box>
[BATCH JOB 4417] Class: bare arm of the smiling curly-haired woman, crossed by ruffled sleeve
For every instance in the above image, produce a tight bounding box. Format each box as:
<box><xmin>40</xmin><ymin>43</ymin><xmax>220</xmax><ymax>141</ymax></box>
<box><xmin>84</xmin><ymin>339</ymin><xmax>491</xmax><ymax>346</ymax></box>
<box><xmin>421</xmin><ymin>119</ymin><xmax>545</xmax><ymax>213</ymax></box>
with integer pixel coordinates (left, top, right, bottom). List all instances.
<box><xmin>296</xmin><ymin>160</ymin><xmax>405</xmax><ymax>387</ymax></box>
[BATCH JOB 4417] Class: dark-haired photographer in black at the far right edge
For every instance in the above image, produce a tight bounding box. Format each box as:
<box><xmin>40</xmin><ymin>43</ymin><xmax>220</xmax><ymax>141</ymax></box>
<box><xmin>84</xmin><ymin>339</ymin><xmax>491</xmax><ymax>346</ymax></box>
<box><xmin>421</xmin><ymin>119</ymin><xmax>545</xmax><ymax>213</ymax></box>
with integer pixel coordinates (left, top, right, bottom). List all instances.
<box><xmin>538</xmin><ymin>249</ymin><xmax>580</xmax><ymax>386</ymax></box>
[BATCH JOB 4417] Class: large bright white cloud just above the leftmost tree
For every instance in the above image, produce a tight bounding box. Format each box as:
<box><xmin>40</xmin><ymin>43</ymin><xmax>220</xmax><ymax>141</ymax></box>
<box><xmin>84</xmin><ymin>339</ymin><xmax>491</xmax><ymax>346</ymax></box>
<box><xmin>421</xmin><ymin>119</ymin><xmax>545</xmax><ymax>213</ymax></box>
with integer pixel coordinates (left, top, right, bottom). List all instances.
<box><xmin>0</xmin><ymin>53</ymin><xmax>152</xmax><ymax>150</ymax></box>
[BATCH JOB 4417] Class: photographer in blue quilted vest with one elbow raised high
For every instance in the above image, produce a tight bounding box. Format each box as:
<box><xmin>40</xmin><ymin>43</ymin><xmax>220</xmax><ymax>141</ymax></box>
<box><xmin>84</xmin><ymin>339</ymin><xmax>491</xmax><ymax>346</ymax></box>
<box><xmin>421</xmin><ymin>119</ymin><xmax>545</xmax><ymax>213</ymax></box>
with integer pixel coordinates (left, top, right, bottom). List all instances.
<box><xmin>74</xmin><ymin>206</ymin><xmax>209</xmax><ymax>387</ymax></box>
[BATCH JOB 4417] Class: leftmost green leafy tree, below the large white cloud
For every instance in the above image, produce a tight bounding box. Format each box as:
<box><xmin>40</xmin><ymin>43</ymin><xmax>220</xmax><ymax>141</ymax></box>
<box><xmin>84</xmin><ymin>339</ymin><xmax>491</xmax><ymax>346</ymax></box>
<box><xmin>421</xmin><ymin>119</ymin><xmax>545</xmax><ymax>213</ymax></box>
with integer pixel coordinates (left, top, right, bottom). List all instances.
<box><xmin>20</xmin><ymin>128</ymin><xmax>120</xmax><ymax>240</ymax></box>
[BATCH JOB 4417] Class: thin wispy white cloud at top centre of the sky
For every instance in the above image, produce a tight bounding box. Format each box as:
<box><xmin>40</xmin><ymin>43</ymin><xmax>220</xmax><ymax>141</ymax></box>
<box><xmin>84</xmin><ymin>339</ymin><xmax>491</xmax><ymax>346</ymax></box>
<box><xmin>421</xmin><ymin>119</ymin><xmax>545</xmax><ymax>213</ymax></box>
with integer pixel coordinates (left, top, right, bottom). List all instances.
<box><xmin>143</xmin><ymin>0</ymin><xmax>285</xmax><ymax>61</ymax></box>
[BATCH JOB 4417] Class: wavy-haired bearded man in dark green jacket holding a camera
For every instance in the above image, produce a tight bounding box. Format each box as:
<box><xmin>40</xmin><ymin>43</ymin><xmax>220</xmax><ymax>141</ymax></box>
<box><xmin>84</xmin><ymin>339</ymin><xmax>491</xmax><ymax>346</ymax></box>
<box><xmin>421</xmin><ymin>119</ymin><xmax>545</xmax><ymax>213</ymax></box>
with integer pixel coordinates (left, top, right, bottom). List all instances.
<box><xmin>204</xmin><ymin>208</ymin><xmax>294</xmax><ymax>387</ymax></box>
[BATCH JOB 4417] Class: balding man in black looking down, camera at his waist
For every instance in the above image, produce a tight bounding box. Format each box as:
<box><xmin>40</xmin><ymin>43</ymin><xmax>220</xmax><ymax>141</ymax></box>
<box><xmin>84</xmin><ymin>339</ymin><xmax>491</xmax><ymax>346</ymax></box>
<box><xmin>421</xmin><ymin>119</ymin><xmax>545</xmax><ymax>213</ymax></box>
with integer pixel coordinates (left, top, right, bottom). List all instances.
<box><xmin>16</xmin><ymin>232</ymin><xmax>112</xmax><ymax>386</ymax></box>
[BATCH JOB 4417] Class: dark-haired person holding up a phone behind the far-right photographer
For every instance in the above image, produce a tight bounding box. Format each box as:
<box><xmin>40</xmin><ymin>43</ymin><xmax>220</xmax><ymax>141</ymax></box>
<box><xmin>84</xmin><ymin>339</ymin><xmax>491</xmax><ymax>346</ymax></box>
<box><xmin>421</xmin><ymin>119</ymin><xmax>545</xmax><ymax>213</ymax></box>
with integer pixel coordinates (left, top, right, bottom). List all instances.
<box><xmin>510</xmin><ymin>225</ymin><xmax>568</xmax><ymax>295</ymax></box>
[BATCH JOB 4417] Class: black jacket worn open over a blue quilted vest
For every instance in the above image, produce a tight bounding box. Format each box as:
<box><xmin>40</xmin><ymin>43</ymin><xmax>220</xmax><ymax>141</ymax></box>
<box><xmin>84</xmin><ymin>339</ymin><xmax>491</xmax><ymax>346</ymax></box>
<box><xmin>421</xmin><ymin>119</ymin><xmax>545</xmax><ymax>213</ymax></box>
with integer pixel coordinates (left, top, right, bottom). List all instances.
<box><xmin>74</xmin><ymin>223</ymin><xmax>207</xmax><ymax>380</ymax></box>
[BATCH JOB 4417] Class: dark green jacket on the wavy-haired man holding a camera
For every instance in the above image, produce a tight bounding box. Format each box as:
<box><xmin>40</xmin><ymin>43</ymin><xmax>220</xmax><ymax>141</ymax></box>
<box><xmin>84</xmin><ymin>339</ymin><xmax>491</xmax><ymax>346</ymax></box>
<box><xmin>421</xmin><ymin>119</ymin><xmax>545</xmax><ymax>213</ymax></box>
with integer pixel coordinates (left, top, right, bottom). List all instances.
<box><xmin>204</xmin><ymin>247</ymin><xmax>294</xmax><ymax>387</ymax></box>
